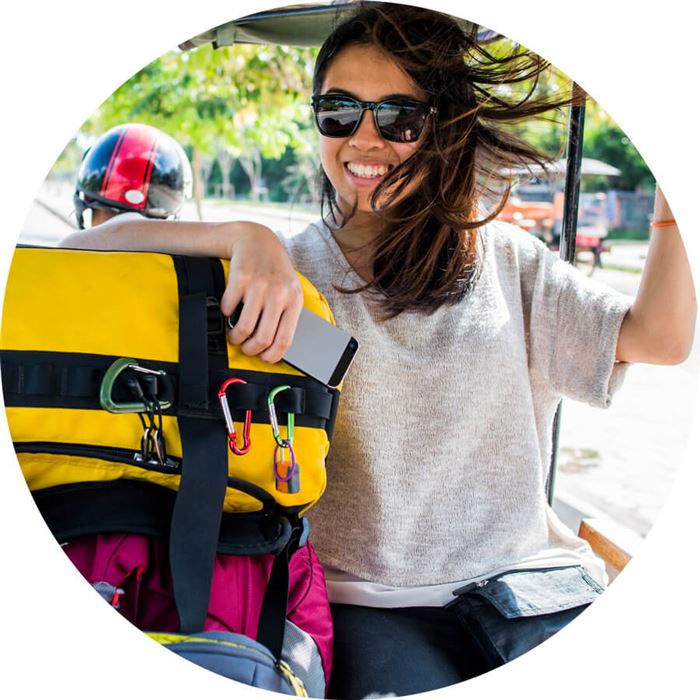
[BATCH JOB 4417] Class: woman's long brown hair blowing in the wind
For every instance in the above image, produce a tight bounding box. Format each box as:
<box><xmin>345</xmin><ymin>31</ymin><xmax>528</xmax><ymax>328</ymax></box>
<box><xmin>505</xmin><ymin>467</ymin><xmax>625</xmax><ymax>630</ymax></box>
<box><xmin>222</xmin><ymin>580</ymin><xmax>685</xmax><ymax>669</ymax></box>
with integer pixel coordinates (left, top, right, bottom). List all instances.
<box><xmin>313</xmin><ymin>2</ymin><xmax>571</xmax><ymax>318</ymax></box>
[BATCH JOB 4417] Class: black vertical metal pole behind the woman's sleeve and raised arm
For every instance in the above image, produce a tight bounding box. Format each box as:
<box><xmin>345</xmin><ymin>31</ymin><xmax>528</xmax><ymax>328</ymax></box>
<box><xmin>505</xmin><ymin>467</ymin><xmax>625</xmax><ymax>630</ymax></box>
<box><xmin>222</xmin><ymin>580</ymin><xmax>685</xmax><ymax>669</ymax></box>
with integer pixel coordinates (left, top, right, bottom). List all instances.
<box><xmin>547</xmin><ymin>83</ymin><xmax>586</xmax><ymax>506</ymax></box>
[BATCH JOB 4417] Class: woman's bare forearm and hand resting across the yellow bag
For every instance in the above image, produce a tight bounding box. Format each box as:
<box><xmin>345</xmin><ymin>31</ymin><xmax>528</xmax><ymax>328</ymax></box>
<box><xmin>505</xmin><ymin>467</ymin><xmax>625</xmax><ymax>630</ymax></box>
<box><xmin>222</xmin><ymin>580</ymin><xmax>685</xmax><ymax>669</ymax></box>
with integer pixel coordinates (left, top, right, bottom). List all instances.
<box><xmin>60</xmin><ymin>216</ymin><xmax>303</xmax><ymax>363</ymax></box>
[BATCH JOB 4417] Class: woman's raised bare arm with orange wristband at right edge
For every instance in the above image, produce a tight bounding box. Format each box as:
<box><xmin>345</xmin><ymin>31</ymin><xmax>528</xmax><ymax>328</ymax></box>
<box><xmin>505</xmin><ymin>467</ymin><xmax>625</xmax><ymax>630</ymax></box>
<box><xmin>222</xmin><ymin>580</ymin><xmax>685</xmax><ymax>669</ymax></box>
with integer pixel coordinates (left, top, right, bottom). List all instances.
<box><xmin>616</xmin><ymin>187</ymin><xmax>697</xmax><ymax>365</ymax></box>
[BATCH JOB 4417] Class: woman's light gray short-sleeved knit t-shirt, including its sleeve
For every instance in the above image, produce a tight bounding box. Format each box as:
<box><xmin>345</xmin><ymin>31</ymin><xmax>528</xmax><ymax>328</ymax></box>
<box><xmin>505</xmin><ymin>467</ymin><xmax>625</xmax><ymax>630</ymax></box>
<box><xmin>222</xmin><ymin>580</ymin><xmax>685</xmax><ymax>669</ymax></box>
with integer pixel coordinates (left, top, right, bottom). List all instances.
<box><xmin>284</xmin><ymin>216</ymin><xmax>631</xmax><ymax>586</ymax></box>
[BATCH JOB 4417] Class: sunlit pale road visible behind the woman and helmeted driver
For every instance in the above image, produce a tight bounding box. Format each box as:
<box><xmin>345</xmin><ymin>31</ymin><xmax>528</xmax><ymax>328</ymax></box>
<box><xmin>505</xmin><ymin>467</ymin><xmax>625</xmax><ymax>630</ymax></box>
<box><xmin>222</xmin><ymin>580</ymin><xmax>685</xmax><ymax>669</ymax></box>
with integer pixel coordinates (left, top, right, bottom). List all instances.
<box><xmin>13</xmin><ymin>186</ymin><xmax>700</xmax><ymax>534</ymax></box>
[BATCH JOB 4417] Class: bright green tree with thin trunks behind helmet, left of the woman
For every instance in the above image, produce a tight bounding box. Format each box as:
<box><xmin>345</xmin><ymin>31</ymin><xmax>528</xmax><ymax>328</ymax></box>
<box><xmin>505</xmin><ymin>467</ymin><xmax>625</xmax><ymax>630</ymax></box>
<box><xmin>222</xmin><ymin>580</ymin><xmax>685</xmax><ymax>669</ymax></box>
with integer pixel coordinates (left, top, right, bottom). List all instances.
<box><xmin>78</xmin><ymin>45</ymin><xmax>313</xmax><ymax>217</ymax></box>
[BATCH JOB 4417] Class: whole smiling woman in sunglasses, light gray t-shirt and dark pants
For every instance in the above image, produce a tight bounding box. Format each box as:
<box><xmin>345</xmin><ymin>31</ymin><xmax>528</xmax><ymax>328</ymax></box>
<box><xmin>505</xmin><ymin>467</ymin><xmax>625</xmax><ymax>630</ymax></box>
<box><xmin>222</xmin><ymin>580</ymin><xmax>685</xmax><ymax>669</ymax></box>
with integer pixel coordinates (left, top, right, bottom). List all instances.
<box><xmin>4</xmin><ymin>3</ymin><xmax>695</xmax><ymax>699</ymax></box>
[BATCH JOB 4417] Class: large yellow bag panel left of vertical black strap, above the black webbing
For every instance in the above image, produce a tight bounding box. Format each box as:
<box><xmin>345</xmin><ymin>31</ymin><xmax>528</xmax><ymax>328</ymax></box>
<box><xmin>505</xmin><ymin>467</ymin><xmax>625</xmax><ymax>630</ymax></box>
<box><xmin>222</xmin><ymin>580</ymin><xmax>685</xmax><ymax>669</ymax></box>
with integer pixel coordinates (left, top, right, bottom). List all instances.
<box><xmin>1</xmin><ymin>248</ymin><xmax>178</xmax><ymax>362</ymax></box>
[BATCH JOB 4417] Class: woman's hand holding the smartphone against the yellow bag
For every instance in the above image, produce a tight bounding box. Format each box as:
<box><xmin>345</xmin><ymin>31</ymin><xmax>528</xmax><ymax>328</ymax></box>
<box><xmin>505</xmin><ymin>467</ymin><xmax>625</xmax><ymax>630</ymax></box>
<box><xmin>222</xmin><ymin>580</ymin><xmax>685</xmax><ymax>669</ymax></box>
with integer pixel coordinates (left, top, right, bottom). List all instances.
<box><xmin>221</xmin><ymin>221</ymin><xmax>304</xmax><ymax>363</ymax></box>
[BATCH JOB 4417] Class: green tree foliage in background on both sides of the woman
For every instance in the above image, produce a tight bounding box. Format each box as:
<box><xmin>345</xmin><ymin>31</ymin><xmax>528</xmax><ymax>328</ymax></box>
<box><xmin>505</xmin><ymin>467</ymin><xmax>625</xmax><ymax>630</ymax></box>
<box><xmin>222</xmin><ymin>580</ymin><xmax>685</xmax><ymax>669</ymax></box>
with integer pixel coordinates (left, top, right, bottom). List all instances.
<box><xmin>53</xmin><ymin>35</ymin><xmax>652</xmax><ymax>209</ymax></box>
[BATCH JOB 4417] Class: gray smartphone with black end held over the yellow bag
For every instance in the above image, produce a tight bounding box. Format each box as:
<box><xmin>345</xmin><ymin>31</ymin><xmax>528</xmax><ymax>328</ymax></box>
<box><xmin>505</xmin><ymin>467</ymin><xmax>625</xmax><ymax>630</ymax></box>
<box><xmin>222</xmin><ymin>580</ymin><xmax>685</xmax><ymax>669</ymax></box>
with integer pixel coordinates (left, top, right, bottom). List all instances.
<box><xmin>226</xmin><ymin>304</ymin><xmax>360</xmax><ymax>387</ymax></box>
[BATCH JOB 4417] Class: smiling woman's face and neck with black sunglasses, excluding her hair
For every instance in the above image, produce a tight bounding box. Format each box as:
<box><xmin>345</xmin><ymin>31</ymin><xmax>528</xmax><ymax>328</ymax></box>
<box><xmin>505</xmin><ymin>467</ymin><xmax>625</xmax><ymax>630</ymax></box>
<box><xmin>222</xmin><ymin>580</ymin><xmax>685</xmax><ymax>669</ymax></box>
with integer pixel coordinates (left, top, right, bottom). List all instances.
<box><xmin>314</xmin><ymin>45</ymin><xmax>435</xmax><ymax>281</ymax></box>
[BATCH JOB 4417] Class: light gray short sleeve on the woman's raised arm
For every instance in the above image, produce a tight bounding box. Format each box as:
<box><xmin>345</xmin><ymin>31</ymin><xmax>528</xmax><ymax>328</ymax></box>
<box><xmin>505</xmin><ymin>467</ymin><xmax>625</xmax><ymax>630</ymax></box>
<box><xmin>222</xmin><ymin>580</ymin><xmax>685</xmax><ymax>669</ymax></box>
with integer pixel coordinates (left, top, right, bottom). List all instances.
<box><xmin>530</xmin><ymin>246</ymin><xmax>633</xmax><ymax>408</ymax></box>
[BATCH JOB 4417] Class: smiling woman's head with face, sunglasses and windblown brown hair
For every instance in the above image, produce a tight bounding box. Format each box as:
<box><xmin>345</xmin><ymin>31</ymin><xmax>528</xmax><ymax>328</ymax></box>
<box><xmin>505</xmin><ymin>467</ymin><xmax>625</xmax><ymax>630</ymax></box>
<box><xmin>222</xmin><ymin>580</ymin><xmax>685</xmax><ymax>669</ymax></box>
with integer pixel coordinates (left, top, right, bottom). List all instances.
<box><xmin>313</xmin><ymin>6</ymin><xmax>570</xmax><ymax>317</ymax></box>
